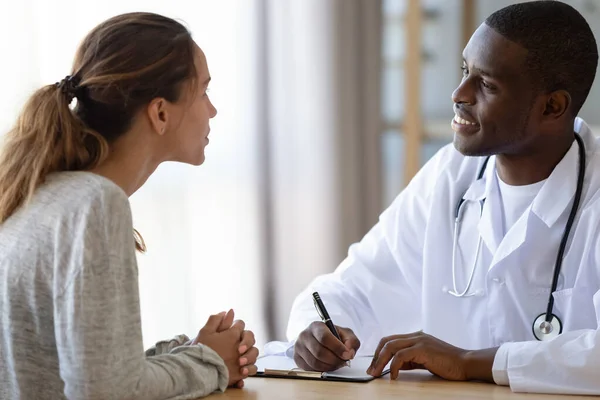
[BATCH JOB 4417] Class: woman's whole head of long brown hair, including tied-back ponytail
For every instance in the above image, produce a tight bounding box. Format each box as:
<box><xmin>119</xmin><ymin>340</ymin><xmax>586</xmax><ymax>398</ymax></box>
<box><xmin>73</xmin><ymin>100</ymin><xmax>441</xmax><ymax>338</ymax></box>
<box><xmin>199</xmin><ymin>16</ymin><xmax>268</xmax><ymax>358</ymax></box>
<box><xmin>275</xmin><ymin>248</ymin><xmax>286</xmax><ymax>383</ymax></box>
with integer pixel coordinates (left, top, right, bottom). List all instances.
<box><xmin>0</xmin><ymin>13</ymin><xmax>196</xmax><ymax>251</ymax></box>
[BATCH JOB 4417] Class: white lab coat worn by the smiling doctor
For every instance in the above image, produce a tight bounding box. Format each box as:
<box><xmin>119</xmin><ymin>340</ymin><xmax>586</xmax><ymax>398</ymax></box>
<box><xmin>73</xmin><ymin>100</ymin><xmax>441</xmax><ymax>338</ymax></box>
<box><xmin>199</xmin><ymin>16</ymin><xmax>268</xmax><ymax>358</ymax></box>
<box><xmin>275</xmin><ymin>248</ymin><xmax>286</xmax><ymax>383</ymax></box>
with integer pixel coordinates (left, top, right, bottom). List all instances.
<box><xmin>288</xmin><ymin>119</ymin><xmax>600</xmax><ymax>394</ymax></box>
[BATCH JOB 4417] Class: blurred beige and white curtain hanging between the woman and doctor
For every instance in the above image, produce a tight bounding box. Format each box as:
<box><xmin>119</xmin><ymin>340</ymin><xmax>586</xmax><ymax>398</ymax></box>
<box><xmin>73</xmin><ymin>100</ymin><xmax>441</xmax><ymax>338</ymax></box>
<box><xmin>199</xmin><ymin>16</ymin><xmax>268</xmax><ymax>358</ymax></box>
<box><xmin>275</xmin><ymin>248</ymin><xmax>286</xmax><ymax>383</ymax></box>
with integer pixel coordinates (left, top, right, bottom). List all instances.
<box><xmin>264</xmin><ymin>0</ymin><xmax>382</xmax><ymax>339</ymax></box>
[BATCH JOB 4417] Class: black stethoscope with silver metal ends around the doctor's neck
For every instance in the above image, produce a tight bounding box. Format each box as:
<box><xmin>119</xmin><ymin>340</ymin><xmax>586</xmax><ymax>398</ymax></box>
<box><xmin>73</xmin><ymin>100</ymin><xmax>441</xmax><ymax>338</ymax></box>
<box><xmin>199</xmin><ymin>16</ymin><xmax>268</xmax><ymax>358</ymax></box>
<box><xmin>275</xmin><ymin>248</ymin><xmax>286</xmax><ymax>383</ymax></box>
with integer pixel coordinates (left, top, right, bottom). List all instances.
<box><xmin>448</xmin><ymin>133</ymin><xmax>585</xmax><ymax>340</ymax></box>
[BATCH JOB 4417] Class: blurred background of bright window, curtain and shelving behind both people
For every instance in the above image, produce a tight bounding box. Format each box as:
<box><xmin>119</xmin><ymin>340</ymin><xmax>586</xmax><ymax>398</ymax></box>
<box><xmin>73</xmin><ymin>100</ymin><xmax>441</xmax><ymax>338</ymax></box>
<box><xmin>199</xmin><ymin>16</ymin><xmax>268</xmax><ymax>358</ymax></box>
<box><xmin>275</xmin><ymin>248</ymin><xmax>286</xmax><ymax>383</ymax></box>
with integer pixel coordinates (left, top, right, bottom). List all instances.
<box><xmin>0</xmin><ymin>0</ymin><xmax>600</xmax><ymax>347</ymax></box>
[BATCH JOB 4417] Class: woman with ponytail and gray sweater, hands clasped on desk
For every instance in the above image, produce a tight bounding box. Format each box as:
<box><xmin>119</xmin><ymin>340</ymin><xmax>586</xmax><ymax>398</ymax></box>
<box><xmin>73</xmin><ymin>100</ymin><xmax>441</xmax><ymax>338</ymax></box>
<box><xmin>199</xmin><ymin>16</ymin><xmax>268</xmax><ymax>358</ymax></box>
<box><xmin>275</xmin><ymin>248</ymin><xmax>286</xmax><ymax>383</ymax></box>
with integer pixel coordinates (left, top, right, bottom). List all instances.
<box><xmin>0</xmin><ymin>13</ymin><xmax>258</xmax><ymax>399</ymax></box>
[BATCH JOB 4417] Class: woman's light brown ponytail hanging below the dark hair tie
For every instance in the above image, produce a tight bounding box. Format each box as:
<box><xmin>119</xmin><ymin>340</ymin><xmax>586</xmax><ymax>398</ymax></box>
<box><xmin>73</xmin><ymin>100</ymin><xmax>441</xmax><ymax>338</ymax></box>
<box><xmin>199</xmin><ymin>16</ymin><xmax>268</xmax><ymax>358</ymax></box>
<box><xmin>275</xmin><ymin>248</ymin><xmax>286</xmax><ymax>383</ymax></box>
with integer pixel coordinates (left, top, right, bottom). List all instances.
<box><xmin>0</xmin><ymin>77</ymin><xmax>146</xmax><ymax>252</ymax></box>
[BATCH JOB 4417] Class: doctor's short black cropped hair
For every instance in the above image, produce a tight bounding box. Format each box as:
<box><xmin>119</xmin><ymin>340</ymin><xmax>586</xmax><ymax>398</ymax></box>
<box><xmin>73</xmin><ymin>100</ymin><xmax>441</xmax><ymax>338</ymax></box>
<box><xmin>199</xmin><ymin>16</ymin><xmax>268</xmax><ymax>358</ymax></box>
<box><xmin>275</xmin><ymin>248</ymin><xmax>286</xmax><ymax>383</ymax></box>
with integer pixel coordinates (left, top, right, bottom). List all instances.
<box><xmin>485</xmin><ymin>0</ymin><xmax>598</xmax><ymax>115</ymax></box>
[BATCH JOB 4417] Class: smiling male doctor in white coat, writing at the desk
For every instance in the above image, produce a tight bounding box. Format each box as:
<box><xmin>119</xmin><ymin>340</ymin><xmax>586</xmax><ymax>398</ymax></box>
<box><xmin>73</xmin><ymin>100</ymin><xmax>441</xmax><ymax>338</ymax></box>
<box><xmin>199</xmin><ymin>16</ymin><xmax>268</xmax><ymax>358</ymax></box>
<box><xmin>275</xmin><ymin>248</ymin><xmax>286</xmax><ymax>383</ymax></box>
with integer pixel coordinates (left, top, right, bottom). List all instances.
<box><xmin>288</xmin><ymin>1</ymin><xmax>600</xmax><ymax>394</ymax></box>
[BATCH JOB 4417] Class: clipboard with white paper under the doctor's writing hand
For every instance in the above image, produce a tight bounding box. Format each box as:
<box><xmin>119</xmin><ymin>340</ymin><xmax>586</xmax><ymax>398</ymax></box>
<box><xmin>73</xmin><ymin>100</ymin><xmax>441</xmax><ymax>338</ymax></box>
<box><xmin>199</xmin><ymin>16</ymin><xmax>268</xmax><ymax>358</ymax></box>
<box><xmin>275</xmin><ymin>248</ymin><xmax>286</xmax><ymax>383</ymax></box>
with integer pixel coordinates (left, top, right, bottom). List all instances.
<box><xmin>254</xmin><ymin>355</ymin><xmax>390</xmax><ymax>383</ymax></box>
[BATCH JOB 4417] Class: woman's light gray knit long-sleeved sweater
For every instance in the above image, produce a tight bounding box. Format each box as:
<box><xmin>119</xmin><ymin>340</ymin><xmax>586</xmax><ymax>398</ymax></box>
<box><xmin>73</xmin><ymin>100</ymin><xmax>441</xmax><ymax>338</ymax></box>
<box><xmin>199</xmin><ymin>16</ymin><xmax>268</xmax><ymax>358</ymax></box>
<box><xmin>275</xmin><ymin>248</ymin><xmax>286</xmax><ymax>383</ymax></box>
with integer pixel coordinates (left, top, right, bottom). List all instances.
<box><xmin>0</xmin><ymin>172</ymin><xmax>228</xmax><ymax>399</ymax></box>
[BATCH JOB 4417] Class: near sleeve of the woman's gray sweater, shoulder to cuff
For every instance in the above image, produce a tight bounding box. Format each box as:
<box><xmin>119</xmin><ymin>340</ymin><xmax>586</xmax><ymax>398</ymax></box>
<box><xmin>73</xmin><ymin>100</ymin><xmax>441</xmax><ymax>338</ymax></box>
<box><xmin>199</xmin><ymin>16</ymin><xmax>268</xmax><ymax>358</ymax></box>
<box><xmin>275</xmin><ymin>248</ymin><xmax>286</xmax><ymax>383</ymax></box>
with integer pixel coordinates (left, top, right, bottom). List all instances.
<box><xmin>54</xmin><ymin>183</ymin><xmax>228</xmax><ymax>399</ymax></box>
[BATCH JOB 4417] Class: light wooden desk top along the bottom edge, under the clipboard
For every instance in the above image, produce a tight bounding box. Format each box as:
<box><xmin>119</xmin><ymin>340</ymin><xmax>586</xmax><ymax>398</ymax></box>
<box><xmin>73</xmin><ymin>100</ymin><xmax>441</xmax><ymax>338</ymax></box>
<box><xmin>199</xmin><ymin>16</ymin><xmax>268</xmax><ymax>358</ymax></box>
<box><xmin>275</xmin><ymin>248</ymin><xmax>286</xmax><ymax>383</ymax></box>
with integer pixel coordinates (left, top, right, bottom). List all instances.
<box><xmin>207</xmin><ymin>371</ymin><xmax>593</xmax><ymax>400</ymax></box>
